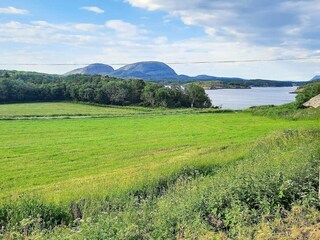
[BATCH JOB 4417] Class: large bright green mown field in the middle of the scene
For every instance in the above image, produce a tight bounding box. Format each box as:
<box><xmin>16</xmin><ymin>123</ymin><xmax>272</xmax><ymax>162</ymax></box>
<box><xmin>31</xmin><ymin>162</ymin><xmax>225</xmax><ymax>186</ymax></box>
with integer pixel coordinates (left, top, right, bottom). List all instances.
<box><xmin>0</xmin><ymin>109</ymin><xmax>320</xmax><ymax>201</ymax></box>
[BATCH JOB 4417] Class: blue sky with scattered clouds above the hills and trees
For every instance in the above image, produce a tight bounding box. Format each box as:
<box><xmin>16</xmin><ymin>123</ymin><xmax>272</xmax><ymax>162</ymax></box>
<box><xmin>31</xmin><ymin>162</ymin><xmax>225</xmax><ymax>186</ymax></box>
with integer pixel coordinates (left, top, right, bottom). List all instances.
<box><xmin>0</xmin><ymin>0</ymin><xmax>320</xmax><ymax>80</ymax></box>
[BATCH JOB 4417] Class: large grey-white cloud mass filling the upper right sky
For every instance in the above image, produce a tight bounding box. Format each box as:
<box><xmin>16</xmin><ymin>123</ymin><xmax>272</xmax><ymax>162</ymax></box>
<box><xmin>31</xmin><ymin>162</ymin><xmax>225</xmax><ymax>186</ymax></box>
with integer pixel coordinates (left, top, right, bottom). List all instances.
<box><xmin>124</xmin><ymin>0</ymin><xmax>320</xmax><ymax>48</ymax></box>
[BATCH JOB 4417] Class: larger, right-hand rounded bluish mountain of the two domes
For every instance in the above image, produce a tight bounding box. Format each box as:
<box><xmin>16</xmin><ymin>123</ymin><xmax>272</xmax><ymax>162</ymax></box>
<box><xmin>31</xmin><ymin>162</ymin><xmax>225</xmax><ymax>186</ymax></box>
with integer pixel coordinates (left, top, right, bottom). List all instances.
<box><xmin>110</xmin><ymin>62</ymin><xmax>178</xmax><ymax>80</ymax></box>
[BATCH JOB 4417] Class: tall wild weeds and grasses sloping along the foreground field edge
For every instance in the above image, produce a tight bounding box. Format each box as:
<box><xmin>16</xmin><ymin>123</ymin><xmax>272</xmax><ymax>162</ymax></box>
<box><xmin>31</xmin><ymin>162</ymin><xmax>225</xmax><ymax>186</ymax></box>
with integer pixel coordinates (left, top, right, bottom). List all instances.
<box><xmin>1</xmin><ymin>129</ymin><xmax>320</xmax><ymax>239</ymax></box>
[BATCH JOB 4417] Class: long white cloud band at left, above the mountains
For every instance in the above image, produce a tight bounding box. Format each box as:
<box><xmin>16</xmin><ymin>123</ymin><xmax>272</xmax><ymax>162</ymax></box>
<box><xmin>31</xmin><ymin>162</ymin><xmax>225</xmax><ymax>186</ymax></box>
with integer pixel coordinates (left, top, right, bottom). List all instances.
<box><xmin>0</xmin><ymin>20</ymin><xmax>147</xmax><ymax>48</ymax></box>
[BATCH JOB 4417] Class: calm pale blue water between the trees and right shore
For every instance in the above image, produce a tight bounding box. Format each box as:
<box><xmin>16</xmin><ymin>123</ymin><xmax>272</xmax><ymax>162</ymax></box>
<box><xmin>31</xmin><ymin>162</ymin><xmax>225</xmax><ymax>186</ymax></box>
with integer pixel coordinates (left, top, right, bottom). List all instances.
<box><xmin>206</xmin><ymin>87</ymin><xmax>297</xmax><ymax>110</ymax></box>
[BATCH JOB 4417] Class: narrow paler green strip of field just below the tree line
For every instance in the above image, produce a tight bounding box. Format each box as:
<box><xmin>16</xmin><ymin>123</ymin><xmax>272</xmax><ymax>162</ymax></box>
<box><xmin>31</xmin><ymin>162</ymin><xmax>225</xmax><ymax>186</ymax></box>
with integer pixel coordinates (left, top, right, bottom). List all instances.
<box><xmin>0</xmin><ymin>102</ymin><xmax>233</xmax><ymax>120</ymax></box>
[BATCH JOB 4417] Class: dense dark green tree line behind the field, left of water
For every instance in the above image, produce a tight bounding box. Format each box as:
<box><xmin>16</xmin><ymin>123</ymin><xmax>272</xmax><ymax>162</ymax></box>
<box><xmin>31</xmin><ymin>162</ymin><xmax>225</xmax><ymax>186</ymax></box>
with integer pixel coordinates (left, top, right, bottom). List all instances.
<box><xmin>0</xmin><ymin>71</ymin><xmax>211</xmax><ymax>108</ymax></box>
